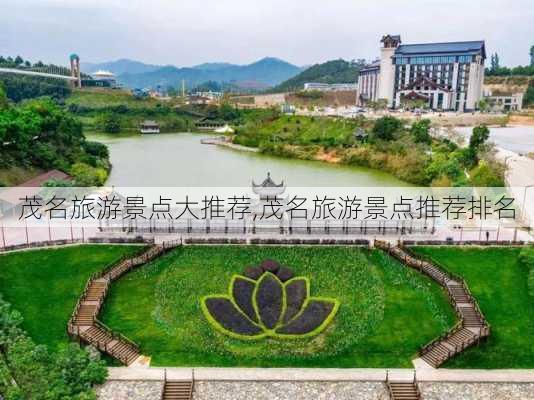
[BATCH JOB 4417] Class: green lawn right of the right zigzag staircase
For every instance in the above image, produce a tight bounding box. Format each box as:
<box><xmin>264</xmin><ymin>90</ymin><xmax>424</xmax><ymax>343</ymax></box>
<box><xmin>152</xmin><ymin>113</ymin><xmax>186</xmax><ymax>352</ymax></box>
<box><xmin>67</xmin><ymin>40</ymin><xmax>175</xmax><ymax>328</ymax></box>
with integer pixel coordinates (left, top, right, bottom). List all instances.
<box><xmin>413</xmin><ymin>247</ymin><xmax>534</xmax><ymax>368</ymax></box>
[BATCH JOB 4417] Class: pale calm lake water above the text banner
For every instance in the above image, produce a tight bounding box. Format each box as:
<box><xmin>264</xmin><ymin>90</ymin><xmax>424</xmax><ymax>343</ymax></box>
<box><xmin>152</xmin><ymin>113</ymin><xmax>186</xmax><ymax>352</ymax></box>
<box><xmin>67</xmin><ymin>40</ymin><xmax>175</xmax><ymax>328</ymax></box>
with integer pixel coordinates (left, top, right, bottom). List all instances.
<box><xmin>88</xmin><ymin>133</ymin><xmax>409</xmax><ymax>187</ymax></box>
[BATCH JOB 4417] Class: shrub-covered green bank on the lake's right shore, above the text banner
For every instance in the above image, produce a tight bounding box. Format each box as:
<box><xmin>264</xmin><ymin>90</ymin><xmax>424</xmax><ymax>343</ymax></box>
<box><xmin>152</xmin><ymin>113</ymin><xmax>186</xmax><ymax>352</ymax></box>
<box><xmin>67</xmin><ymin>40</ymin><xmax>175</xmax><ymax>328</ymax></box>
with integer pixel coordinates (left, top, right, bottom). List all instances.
<box><xmin>234</xmin><ymin>116</ymin><xmax>503</xmax><ymax>186</ymax></box>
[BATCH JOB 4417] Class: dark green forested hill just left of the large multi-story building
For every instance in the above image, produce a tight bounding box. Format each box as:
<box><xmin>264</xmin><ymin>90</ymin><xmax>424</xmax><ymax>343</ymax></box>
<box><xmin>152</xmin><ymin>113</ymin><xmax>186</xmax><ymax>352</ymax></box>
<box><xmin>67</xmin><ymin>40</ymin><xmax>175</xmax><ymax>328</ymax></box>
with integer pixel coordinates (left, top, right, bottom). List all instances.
<box><xmin>272</xmin><ymin>59</ymin><xmax>362</xmax><ymax>92</ymax></box>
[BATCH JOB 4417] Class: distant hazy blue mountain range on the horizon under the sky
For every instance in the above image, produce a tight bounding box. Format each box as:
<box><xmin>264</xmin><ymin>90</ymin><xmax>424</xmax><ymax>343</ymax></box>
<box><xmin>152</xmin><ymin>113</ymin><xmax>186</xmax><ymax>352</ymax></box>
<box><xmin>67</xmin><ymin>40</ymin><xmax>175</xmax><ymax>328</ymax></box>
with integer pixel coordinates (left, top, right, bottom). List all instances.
<box><xmin>118</xmin><ymin>58</ymin><xmax>301</xmax><ymax>88</ymax></box>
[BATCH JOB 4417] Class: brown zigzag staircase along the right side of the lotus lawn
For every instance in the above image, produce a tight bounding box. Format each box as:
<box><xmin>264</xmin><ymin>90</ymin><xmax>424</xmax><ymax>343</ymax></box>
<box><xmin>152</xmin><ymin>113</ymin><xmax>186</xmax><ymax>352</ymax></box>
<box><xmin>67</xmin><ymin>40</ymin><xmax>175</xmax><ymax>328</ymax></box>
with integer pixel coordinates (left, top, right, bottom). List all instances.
<box><xmin>375</xmin><ymin>240</ymin><xmax>490</xmax><ymax>368</ymax></box>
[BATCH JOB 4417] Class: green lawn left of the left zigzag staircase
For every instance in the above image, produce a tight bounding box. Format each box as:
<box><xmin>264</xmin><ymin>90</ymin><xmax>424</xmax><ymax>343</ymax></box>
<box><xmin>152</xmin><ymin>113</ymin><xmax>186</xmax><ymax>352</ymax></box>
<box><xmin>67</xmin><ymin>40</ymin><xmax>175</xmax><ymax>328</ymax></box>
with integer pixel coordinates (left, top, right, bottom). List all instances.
<box><xmin>0</xmin><ymin>245</ymin><xmax>144</xmax><ymax>349</ymax></box>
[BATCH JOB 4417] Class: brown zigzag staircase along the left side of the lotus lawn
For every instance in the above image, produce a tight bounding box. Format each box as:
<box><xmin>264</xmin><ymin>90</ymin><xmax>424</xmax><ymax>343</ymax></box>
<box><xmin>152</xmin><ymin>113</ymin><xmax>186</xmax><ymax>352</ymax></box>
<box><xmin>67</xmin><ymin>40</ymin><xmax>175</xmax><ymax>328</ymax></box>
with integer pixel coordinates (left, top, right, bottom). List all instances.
<box><xmin>67</xmin><ymin>242</ymin><xmax>179</xmax><ymax>365</ymax></box>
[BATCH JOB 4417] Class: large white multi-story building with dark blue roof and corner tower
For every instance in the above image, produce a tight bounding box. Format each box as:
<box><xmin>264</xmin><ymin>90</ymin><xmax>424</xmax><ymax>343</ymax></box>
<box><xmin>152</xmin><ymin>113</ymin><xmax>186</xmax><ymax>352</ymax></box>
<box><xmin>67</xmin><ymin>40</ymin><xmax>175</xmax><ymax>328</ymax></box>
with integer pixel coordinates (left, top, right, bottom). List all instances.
<box><xmin>358</xmin><ymin>35</ymin><xmax>486</xmax><ymax>111</ymax></box>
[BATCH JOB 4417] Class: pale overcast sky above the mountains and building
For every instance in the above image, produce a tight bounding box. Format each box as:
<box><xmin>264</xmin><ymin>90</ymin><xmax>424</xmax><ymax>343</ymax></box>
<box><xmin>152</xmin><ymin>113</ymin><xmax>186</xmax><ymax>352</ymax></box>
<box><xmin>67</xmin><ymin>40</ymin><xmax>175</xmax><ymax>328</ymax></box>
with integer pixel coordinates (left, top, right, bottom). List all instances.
<box><xmin>0</xmin><ymin>0</ymin><xmax>534</xmax><ymax>66</ymax></box>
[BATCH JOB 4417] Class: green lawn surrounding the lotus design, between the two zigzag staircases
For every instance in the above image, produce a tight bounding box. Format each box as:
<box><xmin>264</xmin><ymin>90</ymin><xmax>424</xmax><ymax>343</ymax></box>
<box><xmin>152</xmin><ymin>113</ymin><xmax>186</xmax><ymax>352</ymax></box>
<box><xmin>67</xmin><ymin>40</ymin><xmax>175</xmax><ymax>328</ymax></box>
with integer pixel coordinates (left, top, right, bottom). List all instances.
<box><xmin>102</xmin><ymin>246</ymin><xmax>454</xmax><ymax>367</ymax></box>
